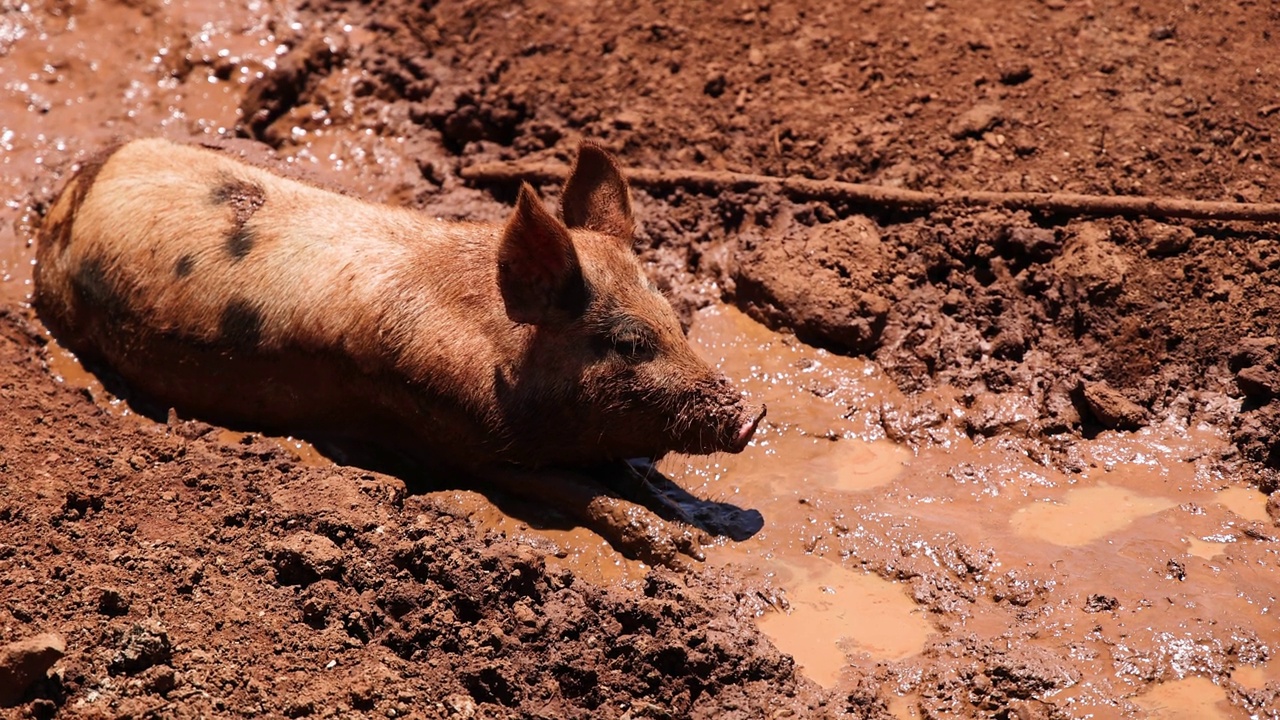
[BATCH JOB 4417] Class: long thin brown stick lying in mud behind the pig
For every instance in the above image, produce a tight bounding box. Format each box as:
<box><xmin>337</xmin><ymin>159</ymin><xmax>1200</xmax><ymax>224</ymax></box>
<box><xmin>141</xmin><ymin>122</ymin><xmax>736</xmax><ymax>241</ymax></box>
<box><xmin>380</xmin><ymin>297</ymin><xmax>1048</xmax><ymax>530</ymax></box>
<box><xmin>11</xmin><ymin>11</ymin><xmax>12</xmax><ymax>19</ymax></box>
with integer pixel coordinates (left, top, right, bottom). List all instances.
<box><xmin>462</xmin><ymin>163</ymin><xmax>1280</xmax><ymax>223</ymax></box>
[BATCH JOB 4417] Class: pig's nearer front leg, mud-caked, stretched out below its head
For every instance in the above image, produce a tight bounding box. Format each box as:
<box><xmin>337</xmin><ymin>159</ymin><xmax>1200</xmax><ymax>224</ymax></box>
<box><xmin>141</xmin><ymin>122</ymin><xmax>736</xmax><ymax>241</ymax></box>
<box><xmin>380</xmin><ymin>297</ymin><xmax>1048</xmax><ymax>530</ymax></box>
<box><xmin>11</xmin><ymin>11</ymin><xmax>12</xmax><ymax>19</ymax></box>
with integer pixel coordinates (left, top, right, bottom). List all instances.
<box><xmin>484</xmin><ymin>468</ymin><xmax>705</xmax><ymax>568</ymax></box>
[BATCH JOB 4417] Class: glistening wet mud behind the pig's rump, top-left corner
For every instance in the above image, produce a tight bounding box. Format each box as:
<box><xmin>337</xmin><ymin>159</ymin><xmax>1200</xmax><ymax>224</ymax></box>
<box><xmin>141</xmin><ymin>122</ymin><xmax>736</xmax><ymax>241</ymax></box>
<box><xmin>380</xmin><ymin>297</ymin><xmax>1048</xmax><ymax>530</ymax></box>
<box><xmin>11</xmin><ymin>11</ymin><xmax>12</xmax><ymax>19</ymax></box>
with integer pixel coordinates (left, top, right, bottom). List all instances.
<box><xmin>0</xmin><ymin>0</ymin><xmax>287</xmax><ymax>301</ymax></box>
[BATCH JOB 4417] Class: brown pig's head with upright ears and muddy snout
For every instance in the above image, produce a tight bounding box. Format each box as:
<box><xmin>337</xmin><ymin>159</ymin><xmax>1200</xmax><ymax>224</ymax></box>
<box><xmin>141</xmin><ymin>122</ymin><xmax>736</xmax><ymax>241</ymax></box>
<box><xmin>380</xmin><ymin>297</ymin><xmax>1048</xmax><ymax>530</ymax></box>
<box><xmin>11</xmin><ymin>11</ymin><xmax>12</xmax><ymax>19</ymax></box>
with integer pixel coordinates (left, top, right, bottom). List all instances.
<box><xmin>498</xmin><ymin>143</ymin><xmax>764</xmax><ymax>461</ymax></box>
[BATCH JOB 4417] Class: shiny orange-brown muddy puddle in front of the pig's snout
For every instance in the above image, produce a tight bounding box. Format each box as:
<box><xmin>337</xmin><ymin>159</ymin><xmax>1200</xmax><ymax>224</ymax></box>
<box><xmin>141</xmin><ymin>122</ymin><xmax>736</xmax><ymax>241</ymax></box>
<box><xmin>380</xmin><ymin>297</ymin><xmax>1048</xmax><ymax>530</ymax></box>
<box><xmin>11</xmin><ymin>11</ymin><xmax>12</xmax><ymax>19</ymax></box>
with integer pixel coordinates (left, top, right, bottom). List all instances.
<box><xmin>655</xmin><ymin>307</ymin><xmax>1280</xmax><ymax>717</ymax></box>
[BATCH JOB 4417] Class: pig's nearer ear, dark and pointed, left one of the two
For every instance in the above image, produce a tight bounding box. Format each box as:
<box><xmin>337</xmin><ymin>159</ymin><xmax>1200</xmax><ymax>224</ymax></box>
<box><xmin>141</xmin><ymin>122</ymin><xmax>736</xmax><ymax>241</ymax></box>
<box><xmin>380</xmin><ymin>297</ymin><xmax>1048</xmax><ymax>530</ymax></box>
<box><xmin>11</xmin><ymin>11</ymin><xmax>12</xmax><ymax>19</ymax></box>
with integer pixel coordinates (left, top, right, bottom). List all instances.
<box><xmin>498</xmin><ymin>183</ymin><xmax>586</xmax><ymax>324</ymax></box>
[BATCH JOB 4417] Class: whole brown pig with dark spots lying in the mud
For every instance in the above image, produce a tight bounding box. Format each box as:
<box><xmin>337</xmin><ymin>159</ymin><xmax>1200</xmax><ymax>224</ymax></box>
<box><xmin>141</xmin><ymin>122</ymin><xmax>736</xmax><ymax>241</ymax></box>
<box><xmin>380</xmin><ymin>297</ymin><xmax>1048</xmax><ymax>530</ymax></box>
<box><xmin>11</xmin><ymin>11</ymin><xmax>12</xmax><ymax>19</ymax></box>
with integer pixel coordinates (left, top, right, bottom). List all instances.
<box><xmin>35</xmin><ymin>138</ymin><xmax>765</xmax><ymax>562</ymax></box>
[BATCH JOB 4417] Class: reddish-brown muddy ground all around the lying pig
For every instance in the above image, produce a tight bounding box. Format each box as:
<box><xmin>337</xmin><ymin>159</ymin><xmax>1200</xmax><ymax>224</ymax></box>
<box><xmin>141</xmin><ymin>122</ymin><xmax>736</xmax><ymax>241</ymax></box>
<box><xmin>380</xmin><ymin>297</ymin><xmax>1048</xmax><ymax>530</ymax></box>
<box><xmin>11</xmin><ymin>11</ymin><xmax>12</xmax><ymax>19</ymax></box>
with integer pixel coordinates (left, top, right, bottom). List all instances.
<box><xmin>0</xmin><ymin>0</ymin><xmax>1280</xmax><ymax>717</ymax></box>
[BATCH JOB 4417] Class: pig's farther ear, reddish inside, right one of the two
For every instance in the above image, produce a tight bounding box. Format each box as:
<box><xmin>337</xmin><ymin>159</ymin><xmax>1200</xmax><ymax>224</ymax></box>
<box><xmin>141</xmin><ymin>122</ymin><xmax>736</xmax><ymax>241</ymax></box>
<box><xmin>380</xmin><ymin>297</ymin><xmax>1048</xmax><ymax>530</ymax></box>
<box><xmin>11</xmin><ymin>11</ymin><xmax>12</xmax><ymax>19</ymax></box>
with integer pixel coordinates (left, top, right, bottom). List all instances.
<box><xmin>561</xmin><ymin>142</ymin><xmax>635</xmax><ymax>240</ymax></box>
